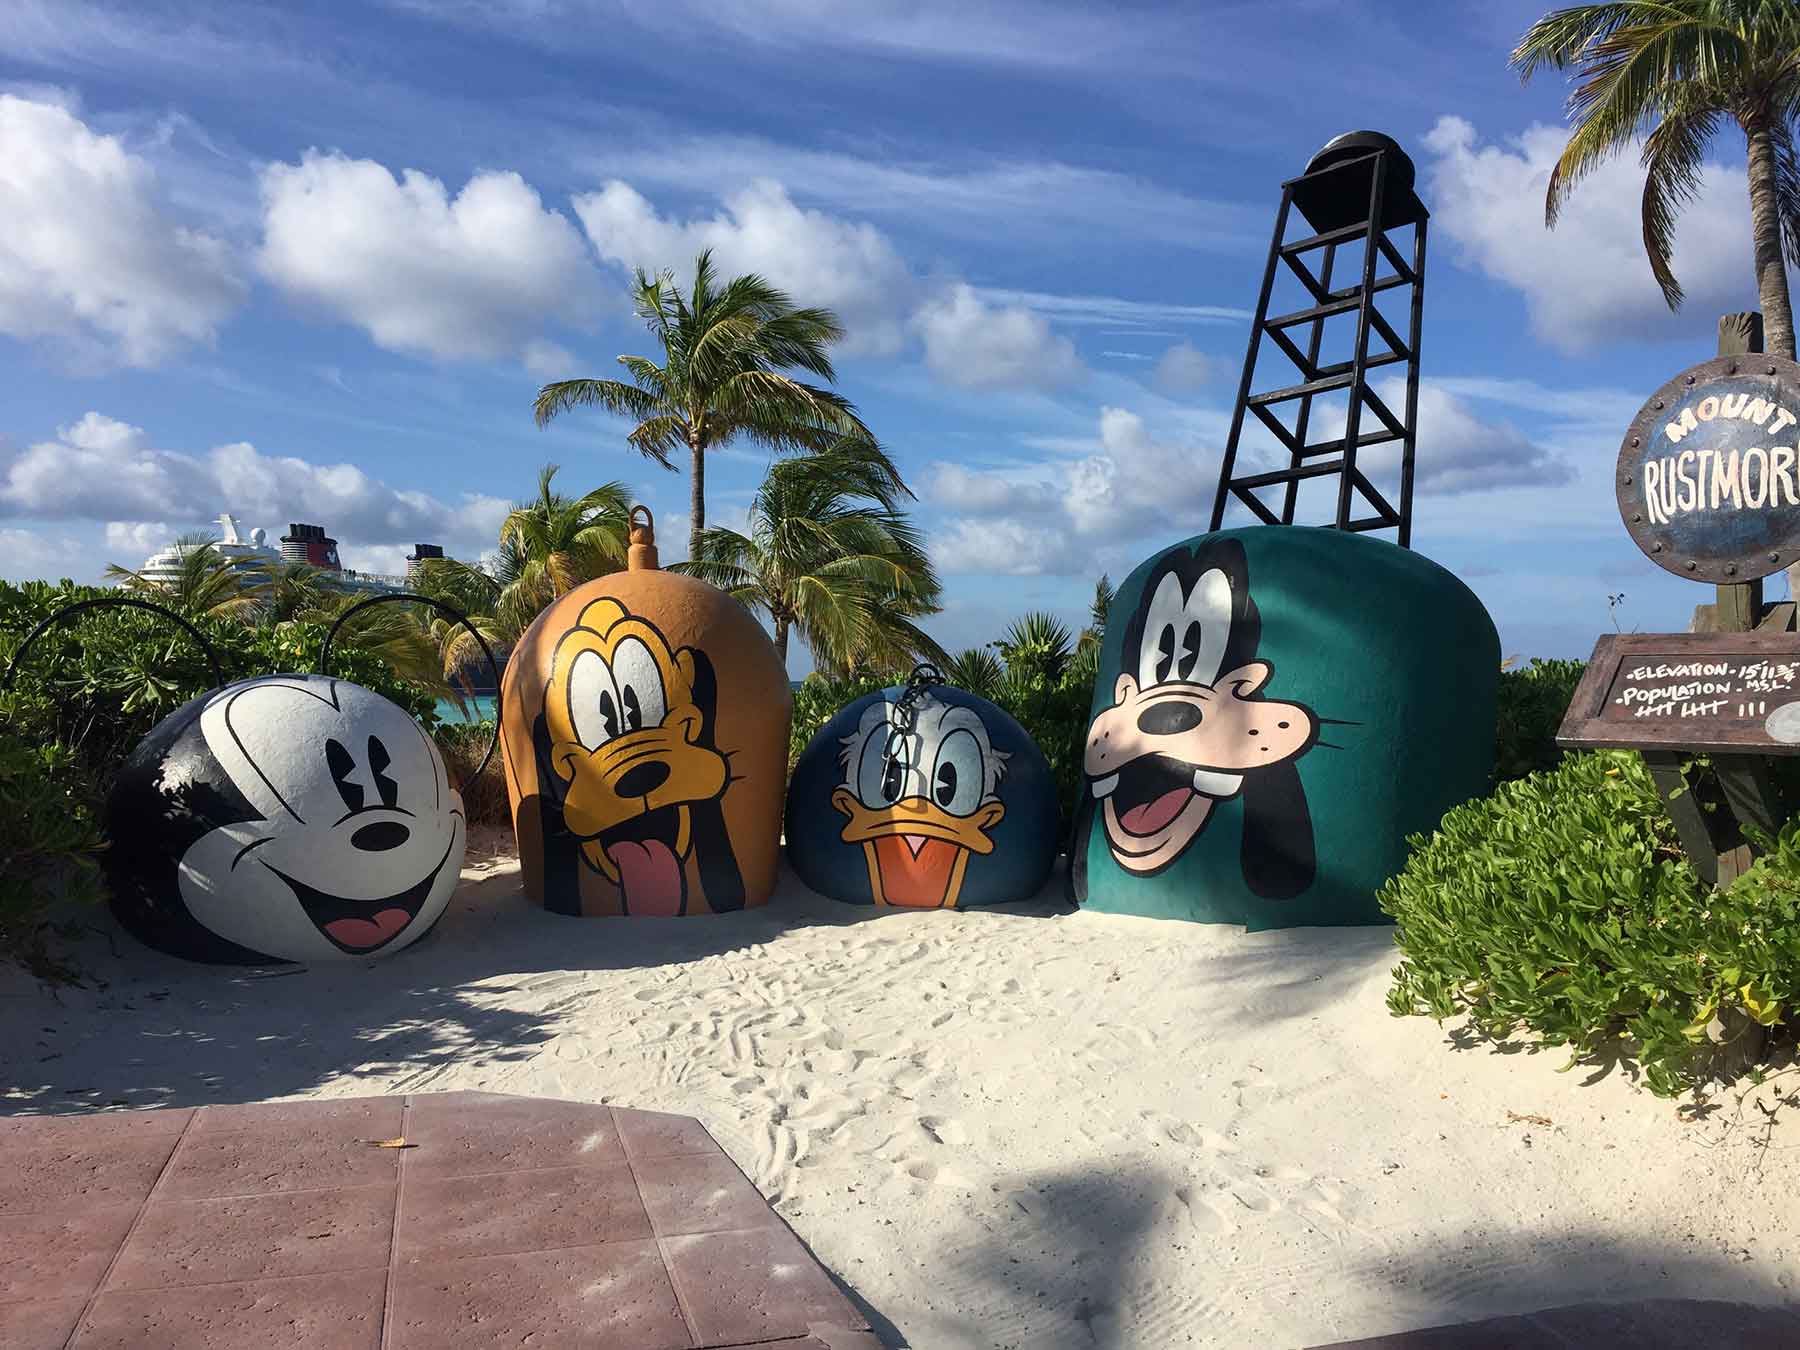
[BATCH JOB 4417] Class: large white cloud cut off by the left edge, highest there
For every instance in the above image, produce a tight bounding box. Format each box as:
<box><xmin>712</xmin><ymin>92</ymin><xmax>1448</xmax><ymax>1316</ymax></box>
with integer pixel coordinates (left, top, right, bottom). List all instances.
<box><xmin>0</xmin><ymin>95</ymin><xmax>245</xmax><ymax>367</ymax></box>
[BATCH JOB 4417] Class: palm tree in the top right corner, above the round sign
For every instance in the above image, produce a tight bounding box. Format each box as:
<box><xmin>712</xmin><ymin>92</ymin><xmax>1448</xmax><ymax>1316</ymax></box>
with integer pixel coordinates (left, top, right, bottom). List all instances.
<box><xmin>1512</xmin><ymin>0</ymin><xmax>1800</xmax><ymax>360</ymax></box>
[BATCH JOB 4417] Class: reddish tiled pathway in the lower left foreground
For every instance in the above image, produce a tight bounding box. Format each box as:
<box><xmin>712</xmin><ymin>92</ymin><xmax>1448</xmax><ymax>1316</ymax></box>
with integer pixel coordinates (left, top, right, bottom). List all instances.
<box><xmin>0</xmin><ymin>1093</ymin><xmax>880</xmax><ymax>1350</ymax></box>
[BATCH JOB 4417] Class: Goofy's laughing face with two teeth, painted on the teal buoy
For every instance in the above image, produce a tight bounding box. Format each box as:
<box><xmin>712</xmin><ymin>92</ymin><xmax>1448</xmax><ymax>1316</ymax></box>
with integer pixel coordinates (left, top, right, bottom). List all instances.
<box><xmin>1082</xmin><ymin>542</ymin><xmax>1318</xmax><ymax>877</ymax></box>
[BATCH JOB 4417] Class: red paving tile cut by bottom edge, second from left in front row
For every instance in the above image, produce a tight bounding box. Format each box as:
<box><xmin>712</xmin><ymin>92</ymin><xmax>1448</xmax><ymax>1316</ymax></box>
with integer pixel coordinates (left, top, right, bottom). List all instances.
<box><xmin>70</xmin><ymin>1271</ymin><xmax>387</xmax><ymax>1350</ymax></box>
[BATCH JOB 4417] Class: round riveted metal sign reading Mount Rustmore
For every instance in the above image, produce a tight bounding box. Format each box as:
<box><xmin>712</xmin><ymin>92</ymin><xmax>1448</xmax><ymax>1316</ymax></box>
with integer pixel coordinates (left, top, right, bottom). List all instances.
<box><xmin>1616</xmin><ymin>353</ymin><xmax>1800</xmax><ymax>583</ymax></box>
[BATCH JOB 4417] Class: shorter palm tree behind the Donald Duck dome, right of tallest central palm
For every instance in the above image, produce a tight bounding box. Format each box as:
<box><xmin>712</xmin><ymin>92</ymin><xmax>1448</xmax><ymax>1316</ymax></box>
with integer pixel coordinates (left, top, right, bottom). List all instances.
<box><xmin>675</xmin><ymin>436</ymin><xmax>947</xmax><ymax>671</ymax></box>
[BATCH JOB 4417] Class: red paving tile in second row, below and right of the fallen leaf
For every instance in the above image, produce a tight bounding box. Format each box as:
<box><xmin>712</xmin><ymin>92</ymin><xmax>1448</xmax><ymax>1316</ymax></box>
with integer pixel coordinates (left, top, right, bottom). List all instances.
<box><xmin>398</xmin><ymin>1161</ymin><xmax>652</xmax><ymax>1260</ymax></box>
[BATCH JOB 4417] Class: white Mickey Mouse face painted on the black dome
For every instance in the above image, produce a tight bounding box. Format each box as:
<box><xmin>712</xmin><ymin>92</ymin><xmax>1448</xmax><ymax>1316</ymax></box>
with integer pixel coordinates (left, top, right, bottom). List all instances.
<box><xmin>180</xmin><ymin>675</ymin><xmax>464</xmax><ymax>961</ymax></box>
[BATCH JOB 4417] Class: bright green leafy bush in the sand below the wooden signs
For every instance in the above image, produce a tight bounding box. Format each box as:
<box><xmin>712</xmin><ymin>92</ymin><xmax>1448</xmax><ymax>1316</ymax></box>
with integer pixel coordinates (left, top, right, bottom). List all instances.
<box><xmin>1381</xmin><ymin>751</ymin><xmax>1800</xmax><ymax>1096</ymax></box>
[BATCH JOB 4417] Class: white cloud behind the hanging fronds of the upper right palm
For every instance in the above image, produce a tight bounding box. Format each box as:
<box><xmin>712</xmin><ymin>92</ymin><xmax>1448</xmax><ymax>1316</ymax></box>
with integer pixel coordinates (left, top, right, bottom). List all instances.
<box><xmin>1426</xmin><ymin>117</ymin><xmax>1757</xmax><ymax>351</ymax></box>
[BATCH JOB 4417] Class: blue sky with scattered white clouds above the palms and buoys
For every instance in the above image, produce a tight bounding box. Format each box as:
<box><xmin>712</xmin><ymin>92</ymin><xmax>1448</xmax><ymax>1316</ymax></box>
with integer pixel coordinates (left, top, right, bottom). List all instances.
<box><xmin>0</xmin><ymin>0</ymin><xmax>1786</xmax><ymax>670</ymax></box>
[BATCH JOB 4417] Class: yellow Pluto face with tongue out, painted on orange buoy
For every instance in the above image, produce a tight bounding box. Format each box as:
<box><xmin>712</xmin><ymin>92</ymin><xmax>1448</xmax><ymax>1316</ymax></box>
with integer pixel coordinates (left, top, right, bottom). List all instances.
<box><xmin>544</xmin><ymin>598</ymin><xmax>729</xmax><ymax>914</ymax></box>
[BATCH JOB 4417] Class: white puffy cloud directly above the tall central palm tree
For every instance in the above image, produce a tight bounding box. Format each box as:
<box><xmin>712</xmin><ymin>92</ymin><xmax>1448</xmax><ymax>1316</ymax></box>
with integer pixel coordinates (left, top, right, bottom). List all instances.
<box><xmin>574</xmin><ymin>180</ymin><xmax>918</xmax><ymax>355</ymax></box>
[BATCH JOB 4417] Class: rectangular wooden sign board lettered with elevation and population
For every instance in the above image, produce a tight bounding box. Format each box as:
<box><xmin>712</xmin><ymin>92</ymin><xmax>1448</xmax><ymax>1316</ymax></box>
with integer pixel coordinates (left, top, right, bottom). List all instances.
<box><xmin>1557</xmin><ymin>632</ymin><xmax>1800</xmax><ymax>754</ymax></box>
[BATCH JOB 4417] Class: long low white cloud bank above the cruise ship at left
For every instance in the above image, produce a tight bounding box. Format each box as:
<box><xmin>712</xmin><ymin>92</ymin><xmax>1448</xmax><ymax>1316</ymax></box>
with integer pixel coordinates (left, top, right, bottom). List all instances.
<box><xmin>0</xmin><ymin>412</ymin><xmax>508</xmax><ymax>562</ymax></box>
